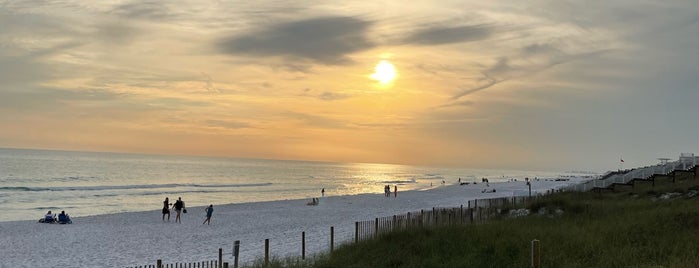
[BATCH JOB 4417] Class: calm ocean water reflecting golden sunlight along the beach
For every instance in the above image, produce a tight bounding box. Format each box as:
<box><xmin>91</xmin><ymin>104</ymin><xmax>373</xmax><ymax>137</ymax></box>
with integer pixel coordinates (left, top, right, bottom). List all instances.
<box><xmin>0</xmin><ymin>148</ymin><xmax>567</xmax><ymax>221</ymax></box>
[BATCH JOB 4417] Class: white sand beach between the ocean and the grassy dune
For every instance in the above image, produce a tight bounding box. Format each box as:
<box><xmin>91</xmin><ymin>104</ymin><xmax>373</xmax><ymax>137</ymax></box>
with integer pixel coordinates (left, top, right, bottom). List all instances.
<box><xmin>0</xmin><ymin>179</ymin><xmax>581</xmax><ymax>267</ymax></box>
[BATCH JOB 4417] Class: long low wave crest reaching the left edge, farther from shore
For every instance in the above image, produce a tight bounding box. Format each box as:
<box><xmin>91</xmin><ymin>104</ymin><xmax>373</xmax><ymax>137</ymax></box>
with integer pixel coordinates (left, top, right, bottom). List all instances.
<box><xmin>0</xmin><ymin>182</ymin><xmax>272</xmax><ymax>192</ymax></box>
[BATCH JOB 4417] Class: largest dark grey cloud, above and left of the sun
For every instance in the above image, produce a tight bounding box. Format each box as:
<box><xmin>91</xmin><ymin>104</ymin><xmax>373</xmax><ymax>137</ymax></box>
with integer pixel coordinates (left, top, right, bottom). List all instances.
<box><xmin>219</xmin><ymin>17</ymin><xmax>374</xmax><ymax>64</ymax></box>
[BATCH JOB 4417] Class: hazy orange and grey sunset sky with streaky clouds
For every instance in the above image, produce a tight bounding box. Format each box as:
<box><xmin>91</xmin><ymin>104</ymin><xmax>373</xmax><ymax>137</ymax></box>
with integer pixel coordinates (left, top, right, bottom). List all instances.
<box><xmin>0</xmin><ymin>0</ymin><xmax>699</xmax><ymax>172</ymax></box>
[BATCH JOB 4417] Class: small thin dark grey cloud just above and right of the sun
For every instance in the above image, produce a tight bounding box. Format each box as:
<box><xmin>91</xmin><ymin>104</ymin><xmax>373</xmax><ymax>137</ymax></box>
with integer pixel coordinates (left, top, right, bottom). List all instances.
<box><xmin>402</xmin><ymin>25</ymin><xmax>496</xmax><ymax>45</ymax></box>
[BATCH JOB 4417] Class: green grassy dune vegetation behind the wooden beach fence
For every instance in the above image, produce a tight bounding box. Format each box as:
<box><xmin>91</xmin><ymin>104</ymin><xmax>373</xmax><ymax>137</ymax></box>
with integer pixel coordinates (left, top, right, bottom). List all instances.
<box><xmin>246</xmin><ymin>174</ymin><xmax>699</xmax><ymax>268</ymax></box>
